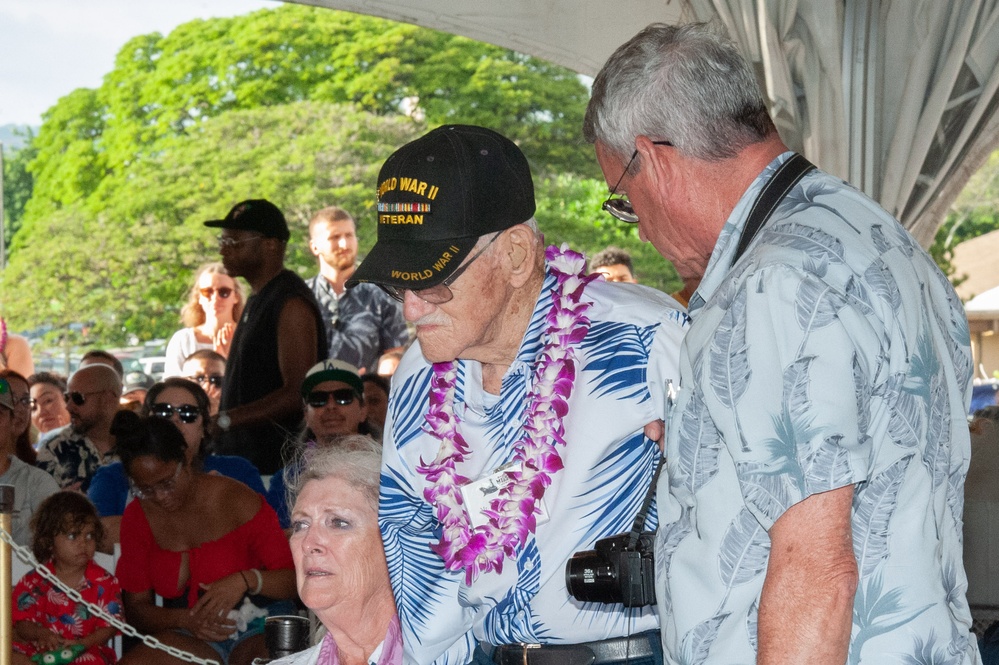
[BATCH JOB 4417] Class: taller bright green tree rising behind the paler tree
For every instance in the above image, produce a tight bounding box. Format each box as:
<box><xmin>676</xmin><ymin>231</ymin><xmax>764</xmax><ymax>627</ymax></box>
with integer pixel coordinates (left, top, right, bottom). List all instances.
<box><xmin>29</xmin><ymin>4</ymin><xmax>598</xmax><ymax>222</ymax></box>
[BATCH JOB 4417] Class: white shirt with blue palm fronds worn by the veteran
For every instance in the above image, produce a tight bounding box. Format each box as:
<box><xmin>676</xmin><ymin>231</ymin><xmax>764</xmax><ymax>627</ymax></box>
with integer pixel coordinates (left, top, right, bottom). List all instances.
<box><xmin>379</xmin><ymin>274</ymin><xmax>687</xmax><ymax>663</ymax></box>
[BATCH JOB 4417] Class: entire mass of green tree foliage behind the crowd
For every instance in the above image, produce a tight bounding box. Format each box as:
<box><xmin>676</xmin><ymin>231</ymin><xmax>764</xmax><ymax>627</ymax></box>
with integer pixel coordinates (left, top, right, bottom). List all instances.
<box><xmin>0</xmin><ymin>4</ymin><xmax>679</xmax><ymax>344</ymax></box>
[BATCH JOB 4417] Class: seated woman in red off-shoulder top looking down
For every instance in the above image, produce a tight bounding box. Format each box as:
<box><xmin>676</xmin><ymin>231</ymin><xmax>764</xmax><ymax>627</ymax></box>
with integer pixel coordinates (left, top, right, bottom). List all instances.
<box><xmin>111</xmin><ymin>410</ymin><xmax>295</xmax><ymax>665</ymax></box>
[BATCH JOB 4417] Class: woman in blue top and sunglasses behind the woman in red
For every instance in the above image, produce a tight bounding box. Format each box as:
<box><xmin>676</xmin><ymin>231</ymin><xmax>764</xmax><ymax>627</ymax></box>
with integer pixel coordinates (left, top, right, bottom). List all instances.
<box><xmin>87</xmin><ymin>377</ymin><xmax>265</xmax><ymax>552</ymax></box>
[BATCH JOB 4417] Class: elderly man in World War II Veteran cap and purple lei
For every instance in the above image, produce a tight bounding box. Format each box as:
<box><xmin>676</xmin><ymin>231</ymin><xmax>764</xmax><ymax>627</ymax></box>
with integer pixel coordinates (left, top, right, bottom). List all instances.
<box><xmin>348</xmin><ymin>125</ymin><xmax>686</xmax><ymax>665</ymax></box>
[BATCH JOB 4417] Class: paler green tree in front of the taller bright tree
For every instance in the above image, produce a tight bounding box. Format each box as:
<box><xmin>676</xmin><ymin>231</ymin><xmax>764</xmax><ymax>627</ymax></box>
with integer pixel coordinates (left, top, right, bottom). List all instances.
<box><xmin>0</xmin><ymin>102</ymin><xmax>422</xmax><ymax>344</ymax></box>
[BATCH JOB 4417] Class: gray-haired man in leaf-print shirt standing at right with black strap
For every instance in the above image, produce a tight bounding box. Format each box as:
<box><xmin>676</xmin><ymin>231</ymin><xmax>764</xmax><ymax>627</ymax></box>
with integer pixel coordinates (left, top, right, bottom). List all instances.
<box><xmin>584</xmin><ymin>24</ymin><xmax>979</xmax><ymax>664</ymax></box>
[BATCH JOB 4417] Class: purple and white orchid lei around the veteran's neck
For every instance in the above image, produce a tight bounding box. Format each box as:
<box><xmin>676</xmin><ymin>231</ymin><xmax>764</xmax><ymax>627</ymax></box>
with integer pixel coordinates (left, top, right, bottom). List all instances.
<box><xmin>417</xmin><ymin>244</ymin><xmax>597</xmax><ymax>584</ymax></box>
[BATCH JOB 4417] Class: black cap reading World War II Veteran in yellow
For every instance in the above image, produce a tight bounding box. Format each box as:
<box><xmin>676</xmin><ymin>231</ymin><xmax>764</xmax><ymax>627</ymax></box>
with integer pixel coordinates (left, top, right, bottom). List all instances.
<box><xmin>347</xmin><ymin>125</ymin><xmax>535</xmax><ymax>290</ymax></box>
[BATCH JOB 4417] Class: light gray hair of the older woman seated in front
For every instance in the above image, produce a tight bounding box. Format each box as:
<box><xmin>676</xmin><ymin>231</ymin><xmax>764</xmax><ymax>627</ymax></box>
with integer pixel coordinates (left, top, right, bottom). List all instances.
<box><xmin>287</xmin><ymin>434</ymin><xmax>382</xmax><ymax>512</ymax></box>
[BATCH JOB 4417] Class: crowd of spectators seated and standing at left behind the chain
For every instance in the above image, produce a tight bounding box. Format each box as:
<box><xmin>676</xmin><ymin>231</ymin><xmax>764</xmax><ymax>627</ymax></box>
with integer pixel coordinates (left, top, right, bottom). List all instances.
<box><xmin>0</xmin><ymin>195</ymin><xmax>409</xmax><ymax>663</ymax></box>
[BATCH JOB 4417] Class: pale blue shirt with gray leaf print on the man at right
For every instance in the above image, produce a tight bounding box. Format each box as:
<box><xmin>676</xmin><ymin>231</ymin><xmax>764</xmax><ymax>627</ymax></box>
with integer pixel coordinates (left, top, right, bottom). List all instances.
<box><xmin>656</xmin><ymin>153</ymin><xmax>979</xmax><ymax>665</ymax></box>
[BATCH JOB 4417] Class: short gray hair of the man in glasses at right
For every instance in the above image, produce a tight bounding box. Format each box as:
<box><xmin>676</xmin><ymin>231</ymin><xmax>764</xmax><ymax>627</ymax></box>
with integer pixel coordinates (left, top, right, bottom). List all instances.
<box><xmin>583</xmin><ymin>23</ymin><xmax>776</xmax><ymax>160</ymax></box>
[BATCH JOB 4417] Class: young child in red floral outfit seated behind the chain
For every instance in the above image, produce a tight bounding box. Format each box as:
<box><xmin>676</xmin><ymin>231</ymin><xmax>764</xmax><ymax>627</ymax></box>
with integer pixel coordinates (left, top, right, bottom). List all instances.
<box><xmin>13</xmin><ymin>491</ymin><xmax>122</xmax><ymax>665</ymax></box>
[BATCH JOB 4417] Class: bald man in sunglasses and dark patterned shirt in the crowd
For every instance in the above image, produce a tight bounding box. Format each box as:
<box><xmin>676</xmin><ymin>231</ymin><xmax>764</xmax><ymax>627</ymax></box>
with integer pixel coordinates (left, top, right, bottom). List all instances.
<box><xmin>38</xmin><ymin>364</ymin><xmax>121</xmax><ymax>492</ymax></box>
